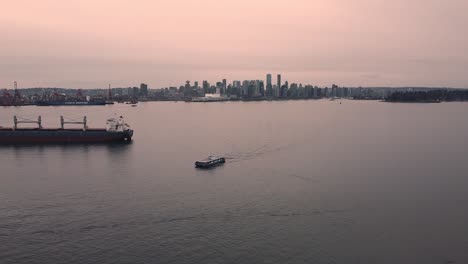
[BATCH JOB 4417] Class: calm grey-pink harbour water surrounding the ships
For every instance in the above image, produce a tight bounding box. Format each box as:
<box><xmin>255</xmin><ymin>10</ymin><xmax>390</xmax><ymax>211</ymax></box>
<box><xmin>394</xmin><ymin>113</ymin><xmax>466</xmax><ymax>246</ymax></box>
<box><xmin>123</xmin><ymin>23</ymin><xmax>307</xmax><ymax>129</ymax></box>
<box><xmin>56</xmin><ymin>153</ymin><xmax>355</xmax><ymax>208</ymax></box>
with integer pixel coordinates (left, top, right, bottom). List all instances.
<box><xmin>0</xmin><ymin>100</ymin><xmax>468</xmax><ymax>263</ymax></box>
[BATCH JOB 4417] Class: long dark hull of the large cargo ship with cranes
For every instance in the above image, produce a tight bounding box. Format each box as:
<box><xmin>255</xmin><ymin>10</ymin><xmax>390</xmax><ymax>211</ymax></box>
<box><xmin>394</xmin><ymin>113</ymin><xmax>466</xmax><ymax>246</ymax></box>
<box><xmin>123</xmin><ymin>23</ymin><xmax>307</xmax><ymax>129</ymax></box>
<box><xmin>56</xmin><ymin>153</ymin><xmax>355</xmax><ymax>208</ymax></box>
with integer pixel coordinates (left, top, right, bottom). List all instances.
<box><xmin>0</xmin><ymin>129</ymin><xmax>133</xmax><ymax>144</ymax></box>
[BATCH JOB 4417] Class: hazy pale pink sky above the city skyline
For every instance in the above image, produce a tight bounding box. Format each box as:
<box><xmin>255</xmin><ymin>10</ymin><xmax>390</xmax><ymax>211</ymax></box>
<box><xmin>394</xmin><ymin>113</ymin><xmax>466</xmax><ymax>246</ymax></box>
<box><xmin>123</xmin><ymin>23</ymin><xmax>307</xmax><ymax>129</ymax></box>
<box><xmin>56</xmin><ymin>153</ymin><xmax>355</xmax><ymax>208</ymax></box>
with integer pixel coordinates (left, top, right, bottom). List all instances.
<box><xmin>0</xmin><ymin>0</ymin><xmax>468</xmax><ymax>88</ymax></box>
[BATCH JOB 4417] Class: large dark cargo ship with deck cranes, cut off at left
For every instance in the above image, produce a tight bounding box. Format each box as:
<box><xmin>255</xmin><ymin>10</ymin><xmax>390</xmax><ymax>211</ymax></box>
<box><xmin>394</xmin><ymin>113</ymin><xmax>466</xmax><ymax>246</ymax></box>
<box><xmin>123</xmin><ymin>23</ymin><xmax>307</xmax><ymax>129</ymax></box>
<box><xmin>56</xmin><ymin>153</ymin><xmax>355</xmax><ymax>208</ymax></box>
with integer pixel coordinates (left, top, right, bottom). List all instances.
<box><xmin>0</xmin><ymin>116</ymin><xmax>133</xmax><ymax>144</ymax></box>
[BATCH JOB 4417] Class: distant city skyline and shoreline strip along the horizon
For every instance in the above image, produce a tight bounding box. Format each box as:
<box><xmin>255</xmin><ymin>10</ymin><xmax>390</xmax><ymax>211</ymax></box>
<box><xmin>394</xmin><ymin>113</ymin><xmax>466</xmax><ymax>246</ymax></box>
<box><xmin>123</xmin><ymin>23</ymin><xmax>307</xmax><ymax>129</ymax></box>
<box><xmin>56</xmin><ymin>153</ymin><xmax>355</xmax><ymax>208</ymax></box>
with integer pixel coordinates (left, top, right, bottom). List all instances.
<box><xmin>4</xmin><ymin>70</ymin><xmax>468</xmax><ymax>106</ymax></box>
